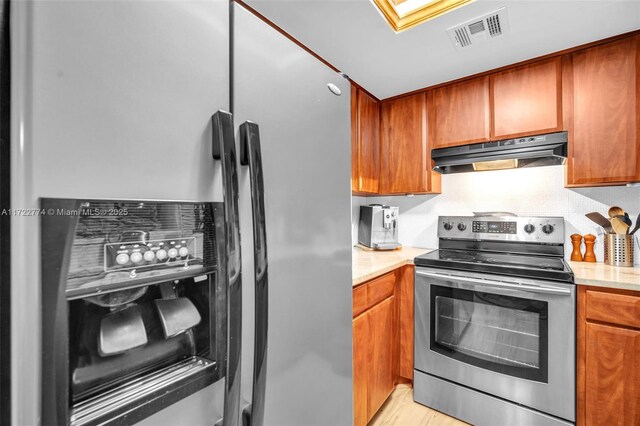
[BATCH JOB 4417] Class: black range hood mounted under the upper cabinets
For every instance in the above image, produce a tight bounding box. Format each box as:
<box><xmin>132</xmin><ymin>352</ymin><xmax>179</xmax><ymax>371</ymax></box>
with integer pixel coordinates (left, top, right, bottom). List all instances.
<box><xmin>431</xmin><ymin>132</ymin><xmax>567</xmax><ymax>174</ymax></box>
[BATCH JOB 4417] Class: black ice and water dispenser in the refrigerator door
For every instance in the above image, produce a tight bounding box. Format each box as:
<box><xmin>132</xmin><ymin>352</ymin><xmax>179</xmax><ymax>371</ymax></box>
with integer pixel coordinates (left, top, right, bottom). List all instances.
<box><xmin>41</xmin><ymin>199</ymin><xmax>227</xmax><ymax>425</ymax></box>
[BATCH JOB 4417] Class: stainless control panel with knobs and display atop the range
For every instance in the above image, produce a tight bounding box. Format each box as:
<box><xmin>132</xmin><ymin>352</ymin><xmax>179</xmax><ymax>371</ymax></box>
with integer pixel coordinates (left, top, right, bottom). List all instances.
<box><xmin>438</xmin><ymin>215</ymin><xmax>564</xmax><ymax>244</ymax></box>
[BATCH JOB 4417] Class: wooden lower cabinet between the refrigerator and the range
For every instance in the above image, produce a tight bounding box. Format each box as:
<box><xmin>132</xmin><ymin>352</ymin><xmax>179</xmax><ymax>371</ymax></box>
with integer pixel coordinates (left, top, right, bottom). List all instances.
<box><xmin>353</xmin><ymin>265</ymin><xmax>414</xmax><ymax>426</ymax></box>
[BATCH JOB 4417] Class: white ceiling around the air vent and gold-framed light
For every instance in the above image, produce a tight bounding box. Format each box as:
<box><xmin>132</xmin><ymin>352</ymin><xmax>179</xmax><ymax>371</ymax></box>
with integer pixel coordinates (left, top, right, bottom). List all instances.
<box><xmin>246</xmin><ymin>0</ymin><xmax>640</xmax><ymax>99</ymax></box>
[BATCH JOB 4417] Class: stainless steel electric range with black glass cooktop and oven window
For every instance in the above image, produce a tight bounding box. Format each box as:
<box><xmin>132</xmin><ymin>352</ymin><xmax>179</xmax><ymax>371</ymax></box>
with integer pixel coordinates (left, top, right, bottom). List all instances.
<box><xmin>414</xmin><ymin>214</ymin><xmax>575</xmax><ymax>426</ymax></box>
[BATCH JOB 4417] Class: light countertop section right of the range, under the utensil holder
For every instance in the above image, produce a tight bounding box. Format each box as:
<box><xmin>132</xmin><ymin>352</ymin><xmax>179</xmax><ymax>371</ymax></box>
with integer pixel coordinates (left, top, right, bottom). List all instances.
<box><xmin>569</xmin><ymin>261</ymin><xmax>640</xmax><ymax>291</ymax></box>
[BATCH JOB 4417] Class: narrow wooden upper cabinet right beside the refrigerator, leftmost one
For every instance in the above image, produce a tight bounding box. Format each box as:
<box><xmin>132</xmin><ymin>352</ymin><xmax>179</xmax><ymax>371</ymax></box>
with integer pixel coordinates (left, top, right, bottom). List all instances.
<box><xmin>351</xmin><ymin>85</ymin><xmax>380</xmax><ymax>194</ymax></box>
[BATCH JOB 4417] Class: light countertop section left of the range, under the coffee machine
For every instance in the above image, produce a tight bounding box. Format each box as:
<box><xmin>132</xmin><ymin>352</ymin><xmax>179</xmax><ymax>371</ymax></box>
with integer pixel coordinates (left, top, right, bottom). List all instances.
<box><xmin>352</xmin><ymin>247</ymin><xmax>434</xmax><ymax>287</ymax></box>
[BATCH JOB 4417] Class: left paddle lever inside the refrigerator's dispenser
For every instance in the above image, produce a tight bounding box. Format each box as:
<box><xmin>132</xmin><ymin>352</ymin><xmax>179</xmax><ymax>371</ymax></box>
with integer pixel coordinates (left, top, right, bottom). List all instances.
<box><xmin>98</xmin><ymin>305</ymin><xmax>147</xmax><ymax>356</ymax></box>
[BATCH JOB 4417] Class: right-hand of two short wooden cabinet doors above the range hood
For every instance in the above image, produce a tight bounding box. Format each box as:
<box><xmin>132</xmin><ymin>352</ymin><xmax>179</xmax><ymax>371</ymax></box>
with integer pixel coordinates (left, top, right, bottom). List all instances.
<box><xmin>489</xmin><ymin>58</ymin><xmax>563</xmax><ymax>140</ymax></box>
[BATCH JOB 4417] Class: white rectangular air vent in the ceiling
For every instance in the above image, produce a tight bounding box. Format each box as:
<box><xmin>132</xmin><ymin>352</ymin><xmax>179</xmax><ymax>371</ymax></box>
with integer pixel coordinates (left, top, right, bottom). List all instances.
<box><xmin>447</xmin><ymin>7</ymin><xmax>509</xmax><ymax>50</ymax></box>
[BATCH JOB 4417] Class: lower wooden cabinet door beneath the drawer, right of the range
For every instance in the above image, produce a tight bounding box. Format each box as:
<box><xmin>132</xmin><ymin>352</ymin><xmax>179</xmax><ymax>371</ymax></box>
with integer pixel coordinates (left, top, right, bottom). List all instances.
<box><xmin>585</xmin><ymin>322</ymin><xmax>640</xmax><ymax>426</ymax></box>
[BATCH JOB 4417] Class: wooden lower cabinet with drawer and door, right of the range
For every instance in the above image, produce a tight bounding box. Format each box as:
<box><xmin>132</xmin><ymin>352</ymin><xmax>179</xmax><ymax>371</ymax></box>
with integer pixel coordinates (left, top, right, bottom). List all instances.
<box><xmin>577</xmin><ymin>286</ymin><xmax>640</xmax><ymax>426</ymax></box>
